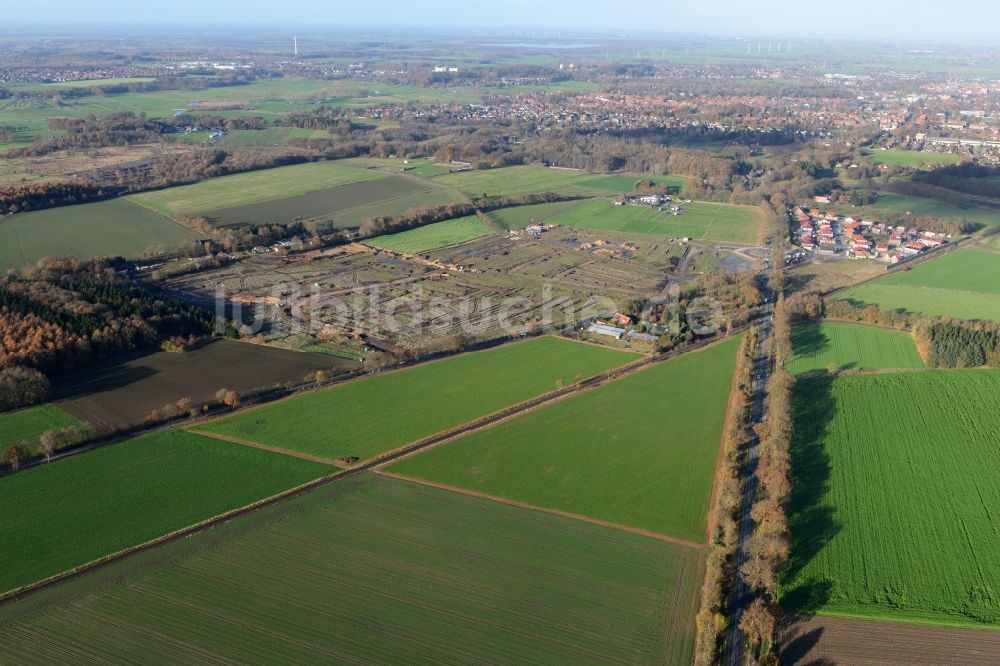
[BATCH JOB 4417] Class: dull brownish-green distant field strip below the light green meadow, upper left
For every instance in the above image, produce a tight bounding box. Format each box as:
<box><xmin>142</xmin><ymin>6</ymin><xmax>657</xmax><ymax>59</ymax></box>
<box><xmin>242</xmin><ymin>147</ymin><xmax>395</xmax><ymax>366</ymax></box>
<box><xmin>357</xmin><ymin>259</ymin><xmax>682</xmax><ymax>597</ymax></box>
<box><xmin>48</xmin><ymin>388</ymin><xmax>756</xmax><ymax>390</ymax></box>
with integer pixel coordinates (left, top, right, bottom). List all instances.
<box><xmin>201</xmin><ymin>176</ymin><xmax>457</xmax><ymax>228</ymax></box>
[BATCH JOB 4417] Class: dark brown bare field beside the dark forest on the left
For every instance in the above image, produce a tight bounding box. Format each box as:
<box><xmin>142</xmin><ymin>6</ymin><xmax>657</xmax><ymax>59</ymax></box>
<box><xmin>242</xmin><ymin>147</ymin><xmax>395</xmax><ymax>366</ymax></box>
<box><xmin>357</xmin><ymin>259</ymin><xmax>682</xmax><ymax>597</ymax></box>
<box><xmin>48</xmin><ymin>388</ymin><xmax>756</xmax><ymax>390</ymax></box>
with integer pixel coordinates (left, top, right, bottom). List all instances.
<box><xmin>53</xmin><ymin>340</ymin><xmax>357</xmax><ymax>425</ymax></box>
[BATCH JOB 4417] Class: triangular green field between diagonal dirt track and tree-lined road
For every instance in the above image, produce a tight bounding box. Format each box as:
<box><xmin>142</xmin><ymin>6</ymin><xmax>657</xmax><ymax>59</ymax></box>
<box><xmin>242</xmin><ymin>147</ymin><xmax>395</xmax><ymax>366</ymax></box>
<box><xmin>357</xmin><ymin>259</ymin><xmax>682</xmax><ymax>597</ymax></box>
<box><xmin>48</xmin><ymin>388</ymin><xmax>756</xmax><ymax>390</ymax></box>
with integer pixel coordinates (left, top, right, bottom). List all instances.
<box><xmin>389</xmin><ymin>339</ymin><xmax>739</xmax><ymax>543</ymax></box>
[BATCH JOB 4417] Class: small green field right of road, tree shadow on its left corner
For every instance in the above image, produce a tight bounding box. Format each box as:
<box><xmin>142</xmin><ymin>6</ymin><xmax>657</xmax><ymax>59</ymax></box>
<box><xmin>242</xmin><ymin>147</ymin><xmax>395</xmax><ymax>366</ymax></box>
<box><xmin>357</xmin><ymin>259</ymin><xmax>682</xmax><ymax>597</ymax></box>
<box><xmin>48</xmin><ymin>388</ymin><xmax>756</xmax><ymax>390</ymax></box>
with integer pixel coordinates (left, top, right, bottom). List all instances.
<box><xmin>785</xmin><ymin>322</ymin><xmax>924</xmax><ymax>375</ymax></box>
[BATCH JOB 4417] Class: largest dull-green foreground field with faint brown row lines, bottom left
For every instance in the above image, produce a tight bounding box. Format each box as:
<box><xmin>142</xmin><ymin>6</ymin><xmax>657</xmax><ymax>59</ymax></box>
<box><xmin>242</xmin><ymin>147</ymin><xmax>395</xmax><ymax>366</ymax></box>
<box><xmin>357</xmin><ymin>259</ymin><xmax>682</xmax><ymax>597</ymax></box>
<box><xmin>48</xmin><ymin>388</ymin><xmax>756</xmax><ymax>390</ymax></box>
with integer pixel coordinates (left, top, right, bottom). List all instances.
<box><xmin>0</xmin><ymin>474</ymin><xmax>704</xmax><ymax>666</ymax></box>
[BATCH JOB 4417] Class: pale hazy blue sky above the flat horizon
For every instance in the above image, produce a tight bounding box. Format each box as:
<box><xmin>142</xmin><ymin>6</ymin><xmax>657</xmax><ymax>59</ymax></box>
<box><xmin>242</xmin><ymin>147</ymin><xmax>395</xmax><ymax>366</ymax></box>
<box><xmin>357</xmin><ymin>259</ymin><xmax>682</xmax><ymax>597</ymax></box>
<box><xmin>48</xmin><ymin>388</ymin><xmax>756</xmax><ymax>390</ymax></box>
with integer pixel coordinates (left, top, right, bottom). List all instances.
<box><xmin>3</xmin><ymin>0</ymin><xmax>1000</xmax><ymax>42</ymax></box>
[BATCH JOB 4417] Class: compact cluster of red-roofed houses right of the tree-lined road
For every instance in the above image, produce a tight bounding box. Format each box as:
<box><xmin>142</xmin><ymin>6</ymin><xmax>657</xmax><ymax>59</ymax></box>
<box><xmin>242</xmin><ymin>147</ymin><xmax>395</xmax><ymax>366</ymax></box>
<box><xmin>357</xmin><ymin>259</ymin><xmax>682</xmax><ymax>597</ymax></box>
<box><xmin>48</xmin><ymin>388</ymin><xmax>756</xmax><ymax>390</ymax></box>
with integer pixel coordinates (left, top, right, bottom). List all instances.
<box><xmin>792</xmin><ymin>206</ymin><xmax>951</xmax><ymax>264</ymax></box>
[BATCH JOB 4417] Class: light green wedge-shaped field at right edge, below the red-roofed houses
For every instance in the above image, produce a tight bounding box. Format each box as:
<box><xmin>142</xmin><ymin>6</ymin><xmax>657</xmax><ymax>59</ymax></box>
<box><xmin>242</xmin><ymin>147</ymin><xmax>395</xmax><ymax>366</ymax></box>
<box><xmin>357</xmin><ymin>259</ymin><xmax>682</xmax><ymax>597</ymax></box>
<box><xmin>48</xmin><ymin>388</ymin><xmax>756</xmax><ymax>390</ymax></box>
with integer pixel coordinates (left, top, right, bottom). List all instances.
<box><xmin>838</xmin><ymin>248</ymin><xmax>1000</xmax><ymax>321</ymax></box>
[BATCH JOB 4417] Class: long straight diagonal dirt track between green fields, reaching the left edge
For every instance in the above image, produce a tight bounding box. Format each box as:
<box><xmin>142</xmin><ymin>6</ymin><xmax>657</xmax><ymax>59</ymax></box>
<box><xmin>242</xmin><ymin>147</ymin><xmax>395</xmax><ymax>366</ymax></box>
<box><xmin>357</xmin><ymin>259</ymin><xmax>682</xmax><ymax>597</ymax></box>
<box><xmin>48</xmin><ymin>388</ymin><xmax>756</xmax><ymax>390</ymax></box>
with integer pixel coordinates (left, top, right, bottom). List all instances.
<box><xmin>0</xmin><ymin>320</ymin><xmax>757</xmax><ymax>605</ymax></box>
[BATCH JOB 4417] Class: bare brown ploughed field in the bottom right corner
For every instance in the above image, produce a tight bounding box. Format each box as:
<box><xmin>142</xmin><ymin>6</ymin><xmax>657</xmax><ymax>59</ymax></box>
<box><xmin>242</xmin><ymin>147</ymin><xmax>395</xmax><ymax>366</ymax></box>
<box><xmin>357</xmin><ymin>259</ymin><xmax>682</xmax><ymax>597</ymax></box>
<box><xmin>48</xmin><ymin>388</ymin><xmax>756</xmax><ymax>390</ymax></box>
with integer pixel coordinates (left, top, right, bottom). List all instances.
<box><xmin>781</xmin><ymin>616</ymin><xmax>1000</xmax><ymax>666</ymax></box>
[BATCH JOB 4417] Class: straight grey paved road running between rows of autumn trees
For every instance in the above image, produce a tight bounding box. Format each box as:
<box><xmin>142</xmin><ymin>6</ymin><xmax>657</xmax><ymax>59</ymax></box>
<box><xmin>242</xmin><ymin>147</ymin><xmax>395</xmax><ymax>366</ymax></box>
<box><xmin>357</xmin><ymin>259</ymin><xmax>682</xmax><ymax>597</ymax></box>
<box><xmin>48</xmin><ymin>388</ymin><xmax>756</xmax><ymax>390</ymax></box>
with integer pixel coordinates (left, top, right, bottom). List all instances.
<box><xmin>725</xmin><ymin>278</ymin><xmax>774</xmax><ymax>666</ymax></box>
